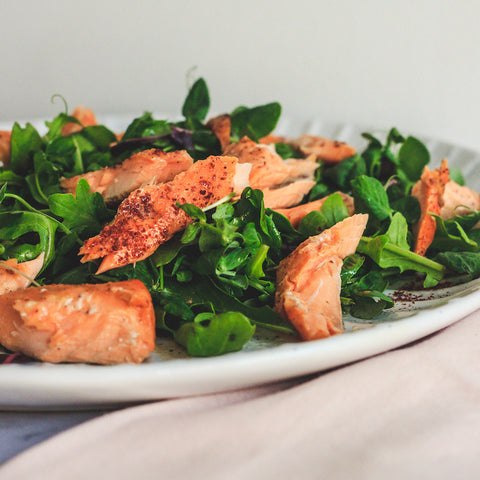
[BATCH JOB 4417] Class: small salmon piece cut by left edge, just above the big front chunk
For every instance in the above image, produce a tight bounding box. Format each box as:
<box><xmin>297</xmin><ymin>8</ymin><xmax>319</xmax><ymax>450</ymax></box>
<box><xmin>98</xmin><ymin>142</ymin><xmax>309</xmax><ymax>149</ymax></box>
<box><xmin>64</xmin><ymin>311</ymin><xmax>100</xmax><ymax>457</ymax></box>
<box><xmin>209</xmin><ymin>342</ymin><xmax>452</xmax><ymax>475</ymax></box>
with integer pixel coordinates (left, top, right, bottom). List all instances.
<box><xmin>0</xmin><ymin>252</ymin><xmax>45</xmax><ymax>295</ymax></box>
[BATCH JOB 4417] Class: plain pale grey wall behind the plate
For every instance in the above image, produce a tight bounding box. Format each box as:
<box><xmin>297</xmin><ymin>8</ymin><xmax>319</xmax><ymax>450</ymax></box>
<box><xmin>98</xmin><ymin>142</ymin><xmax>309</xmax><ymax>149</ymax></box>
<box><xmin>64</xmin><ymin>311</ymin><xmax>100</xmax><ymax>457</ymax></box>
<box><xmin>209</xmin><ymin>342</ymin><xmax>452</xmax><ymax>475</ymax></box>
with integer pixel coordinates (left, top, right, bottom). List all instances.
<box><xmin>0</xmin><ymin>0</ymin><xmax>480</xmax><ymax>150</ymax></box>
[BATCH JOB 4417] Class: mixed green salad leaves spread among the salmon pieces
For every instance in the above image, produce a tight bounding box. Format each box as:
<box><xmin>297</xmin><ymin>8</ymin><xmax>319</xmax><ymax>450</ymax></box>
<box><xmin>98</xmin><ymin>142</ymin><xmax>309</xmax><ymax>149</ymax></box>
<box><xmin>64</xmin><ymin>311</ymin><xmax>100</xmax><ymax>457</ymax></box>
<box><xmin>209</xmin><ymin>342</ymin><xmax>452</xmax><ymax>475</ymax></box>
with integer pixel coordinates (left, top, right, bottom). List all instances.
<box><xmin>0</xmin><ymin>78</ymin><xmax>480</xmax><ymax>356</ymax></box>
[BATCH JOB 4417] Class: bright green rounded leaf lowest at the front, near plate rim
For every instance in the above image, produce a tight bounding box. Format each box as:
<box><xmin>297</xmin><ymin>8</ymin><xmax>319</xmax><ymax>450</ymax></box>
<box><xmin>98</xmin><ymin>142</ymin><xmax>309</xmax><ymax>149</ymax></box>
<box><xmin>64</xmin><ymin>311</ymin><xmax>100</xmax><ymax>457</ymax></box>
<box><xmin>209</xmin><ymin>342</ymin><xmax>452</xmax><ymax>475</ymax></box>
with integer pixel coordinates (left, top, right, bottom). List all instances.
<box><xmin>174</xmin><ymin>312</ymin><xmax>255</xmax><ymax>357</ymax></box>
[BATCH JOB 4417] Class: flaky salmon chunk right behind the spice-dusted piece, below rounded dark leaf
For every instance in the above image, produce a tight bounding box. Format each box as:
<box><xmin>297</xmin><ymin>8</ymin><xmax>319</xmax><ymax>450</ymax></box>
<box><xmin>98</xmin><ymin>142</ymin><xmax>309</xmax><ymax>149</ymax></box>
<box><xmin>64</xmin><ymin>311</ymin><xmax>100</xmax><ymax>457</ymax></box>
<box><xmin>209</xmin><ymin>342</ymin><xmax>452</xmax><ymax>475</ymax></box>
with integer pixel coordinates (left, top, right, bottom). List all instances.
<box><xmin>224</xmin><ymin>137</ymin><xmax>318</xmax><ymax>190</ymax></box>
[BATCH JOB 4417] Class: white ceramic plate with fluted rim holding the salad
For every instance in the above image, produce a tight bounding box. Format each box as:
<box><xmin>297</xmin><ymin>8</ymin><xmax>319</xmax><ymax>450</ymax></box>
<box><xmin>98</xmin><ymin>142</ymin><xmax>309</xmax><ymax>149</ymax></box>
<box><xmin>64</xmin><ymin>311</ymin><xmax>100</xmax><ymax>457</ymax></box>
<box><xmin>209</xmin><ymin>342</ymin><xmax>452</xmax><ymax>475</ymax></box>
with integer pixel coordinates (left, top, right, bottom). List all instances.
<box><xmin>0</xmin><ymin>117</ymin><xmax>480</xmax><ymax>409</ymax></box>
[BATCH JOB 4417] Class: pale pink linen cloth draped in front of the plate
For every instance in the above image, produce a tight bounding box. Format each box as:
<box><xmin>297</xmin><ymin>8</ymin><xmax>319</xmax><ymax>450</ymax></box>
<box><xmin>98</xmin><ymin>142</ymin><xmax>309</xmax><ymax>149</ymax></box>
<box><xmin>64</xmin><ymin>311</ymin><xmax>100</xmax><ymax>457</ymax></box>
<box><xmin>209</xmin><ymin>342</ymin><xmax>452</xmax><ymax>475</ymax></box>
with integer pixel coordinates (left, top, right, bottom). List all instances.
<box><xmin>0</xmin><ymin>312</ymin><xmax>480</xmax><ymax>480</ymax></box>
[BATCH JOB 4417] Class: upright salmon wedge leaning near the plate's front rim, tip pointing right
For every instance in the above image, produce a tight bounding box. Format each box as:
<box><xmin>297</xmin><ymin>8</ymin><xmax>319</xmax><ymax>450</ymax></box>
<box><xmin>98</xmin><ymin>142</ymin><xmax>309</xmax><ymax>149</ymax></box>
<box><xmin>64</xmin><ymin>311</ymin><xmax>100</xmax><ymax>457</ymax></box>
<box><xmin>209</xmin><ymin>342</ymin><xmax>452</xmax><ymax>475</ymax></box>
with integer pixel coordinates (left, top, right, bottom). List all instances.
<box><xmin>274</xmin><ymin>214</ymin><xmax>368</xmax><ymax>340</ymax></box>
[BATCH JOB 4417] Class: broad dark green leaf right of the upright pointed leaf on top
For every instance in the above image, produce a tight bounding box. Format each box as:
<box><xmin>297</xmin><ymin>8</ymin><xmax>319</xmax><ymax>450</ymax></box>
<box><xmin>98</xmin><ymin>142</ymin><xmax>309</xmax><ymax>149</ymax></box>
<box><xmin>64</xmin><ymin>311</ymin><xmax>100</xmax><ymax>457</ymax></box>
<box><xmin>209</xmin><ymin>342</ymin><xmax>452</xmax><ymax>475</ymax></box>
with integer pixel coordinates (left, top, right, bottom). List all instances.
<box><xmin>230</xmin><ymin>102</ymin><xmax>282</xmax><ymax>141</ymax></box>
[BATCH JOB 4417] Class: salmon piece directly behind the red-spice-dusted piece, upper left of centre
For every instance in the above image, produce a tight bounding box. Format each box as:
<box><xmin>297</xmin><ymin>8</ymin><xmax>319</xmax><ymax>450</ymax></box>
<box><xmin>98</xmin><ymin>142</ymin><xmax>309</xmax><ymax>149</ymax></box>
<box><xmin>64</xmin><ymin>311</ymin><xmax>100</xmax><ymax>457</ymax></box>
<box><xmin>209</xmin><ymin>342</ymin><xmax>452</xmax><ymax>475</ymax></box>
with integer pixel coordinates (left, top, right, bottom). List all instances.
<box><xmin>60</xmin><ymin>148</ymin><xmax>193</xmax><ymax>203</ymax></box>
